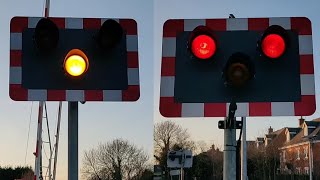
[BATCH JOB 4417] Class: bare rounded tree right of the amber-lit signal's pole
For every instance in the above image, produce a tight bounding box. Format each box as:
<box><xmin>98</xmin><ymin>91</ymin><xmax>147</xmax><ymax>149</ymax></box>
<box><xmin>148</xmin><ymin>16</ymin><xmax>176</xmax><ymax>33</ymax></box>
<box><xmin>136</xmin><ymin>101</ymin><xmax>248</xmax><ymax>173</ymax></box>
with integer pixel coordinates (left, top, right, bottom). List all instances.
<box><xmin>82</xmin><ymin>139</ymin><xmax>148</xmax><ymax>180</ymax></box>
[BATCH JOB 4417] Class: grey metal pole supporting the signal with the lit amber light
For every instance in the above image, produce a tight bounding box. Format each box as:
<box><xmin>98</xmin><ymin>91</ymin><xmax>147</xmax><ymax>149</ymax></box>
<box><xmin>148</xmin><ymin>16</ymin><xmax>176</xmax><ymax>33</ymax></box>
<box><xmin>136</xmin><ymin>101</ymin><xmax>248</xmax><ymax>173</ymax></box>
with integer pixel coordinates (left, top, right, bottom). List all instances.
<box><xmin>68</xmin><ymin>102</ymin><xmax>78</xmax><ymax>180</ymax></box>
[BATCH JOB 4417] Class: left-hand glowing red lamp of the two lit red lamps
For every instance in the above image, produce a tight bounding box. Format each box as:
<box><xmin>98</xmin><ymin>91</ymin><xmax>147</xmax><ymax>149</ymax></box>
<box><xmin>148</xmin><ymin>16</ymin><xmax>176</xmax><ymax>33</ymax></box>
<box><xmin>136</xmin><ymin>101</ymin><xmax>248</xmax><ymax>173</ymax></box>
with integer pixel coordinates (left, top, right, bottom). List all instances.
<box><xmin>191</xmin><ymin>35</ymin><xmax>217</xmax><ymax>59</ymax></box>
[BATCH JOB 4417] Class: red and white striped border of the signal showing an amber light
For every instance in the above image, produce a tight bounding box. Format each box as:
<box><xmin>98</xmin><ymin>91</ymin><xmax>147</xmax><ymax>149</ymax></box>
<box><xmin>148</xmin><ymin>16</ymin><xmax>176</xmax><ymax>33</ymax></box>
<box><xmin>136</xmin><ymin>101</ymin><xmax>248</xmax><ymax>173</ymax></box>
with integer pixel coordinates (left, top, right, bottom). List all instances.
<box><xmin>9</xmin><ymin>17</ymin><xmax>140</xmax><ymax>101</ymax></box>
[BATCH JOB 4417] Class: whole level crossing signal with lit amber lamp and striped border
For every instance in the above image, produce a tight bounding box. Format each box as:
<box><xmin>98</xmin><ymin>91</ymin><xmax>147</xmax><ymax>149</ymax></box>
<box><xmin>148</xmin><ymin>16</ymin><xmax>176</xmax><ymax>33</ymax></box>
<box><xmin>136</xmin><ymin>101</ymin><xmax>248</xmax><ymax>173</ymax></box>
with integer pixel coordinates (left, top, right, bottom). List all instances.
<box><xmin>9</xmin><ymin>17</ymin><xmax>140</xmax><ymax>101</ymax></box>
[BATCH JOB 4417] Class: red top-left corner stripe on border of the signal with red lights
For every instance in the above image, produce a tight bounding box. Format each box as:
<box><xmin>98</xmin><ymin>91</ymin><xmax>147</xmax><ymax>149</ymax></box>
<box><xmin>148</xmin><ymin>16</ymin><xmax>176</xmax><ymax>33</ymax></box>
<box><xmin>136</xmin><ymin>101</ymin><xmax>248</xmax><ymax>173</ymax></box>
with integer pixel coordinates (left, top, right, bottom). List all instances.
<box><xmin>163</xmin><ymin>19</ymin><xmax>184</xmax><ymax>37</ymax></box>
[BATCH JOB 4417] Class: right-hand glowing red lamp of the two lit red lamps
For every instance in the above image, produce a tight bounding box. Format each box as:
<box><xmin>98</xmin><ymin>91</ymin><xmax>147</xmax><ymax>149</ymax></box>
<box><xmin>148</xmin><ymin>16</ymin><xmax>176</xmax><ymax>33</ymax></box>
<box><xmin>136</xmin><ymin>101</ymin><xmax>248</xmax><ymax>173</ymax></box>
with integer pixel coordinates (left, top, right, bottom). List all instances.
<box><xmin>261</xmin><ymin>34</ymin><xmax>286</xmax><ymax>59</ymax></box>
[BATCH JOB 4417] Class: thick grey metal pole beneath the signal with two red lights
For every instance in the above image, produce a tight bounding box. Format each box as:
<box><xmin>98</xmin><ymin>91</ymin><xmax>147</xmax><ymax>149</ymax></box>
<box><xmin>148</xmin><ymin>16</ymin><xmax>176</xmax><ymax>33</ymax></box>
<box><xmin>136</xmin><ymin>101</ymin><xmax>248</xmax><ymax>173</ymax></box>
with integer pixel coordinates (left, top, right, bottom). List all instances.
<box><xmin>223</xmin><ymin>118</ymin><xmax>236</xmax><ymax>180</ymax></box>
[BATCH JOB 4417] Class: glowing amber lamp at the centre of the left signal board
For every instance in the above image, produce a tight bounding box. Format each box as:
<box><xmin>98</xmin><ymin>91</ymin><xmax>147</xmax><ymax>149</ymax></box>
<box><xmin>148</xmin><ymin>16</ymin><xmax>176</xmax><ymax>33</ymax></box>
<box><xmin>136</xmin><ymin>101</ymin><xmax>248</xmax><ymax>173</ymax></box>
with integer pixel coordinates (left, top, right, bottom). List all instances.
<box><xmin>64</xmin><ymin>49</ymin><xmax>89</xmax><ymax>77</ymax></box>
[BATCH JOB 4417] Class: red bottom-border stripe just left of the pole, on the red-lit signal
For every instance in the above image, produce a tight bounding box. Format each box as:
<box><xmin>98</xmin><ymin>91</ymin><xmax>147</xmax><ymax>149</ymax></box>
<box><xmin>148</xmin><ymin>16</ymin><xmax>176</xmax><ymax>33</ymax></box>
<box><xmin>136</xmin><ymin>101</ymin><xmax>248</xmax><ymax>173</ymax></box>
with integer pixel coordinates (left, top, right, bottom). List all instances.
<box><xmin>204</xmin><ymin>103</ymin><xmax>227</xmax><ymax>117</ymax></box>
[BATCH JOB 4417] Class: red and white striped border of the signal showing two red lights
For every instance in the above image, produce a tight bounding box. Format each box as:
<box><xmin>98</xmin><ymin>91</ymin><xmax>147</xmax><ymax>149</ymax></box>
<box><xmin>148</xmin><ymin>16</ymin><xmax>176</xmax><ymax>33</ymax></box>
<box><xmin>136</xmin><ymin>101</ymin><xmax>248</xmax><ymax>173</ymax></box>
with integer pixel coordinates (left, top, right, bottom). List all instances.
<box><xmin>160</xmin><ymin>17</ymin><xmax>316</xmax><ymax>117</ymax></box>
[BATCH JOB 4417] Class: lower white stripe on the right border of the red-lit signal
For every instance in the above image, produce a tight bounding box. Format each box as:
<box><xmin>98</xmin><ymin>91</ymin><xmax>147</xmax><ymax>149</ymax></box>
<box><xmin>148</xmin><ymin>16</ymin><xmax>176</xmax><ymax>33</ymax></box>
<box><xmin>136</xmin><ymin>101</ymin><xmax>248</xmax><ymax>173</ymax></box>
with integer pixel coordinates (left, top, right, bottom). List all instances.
<box><xmin>300</xmin><ymin>74</ymin><xmax>315</xmax><ymax>95</ymax></box>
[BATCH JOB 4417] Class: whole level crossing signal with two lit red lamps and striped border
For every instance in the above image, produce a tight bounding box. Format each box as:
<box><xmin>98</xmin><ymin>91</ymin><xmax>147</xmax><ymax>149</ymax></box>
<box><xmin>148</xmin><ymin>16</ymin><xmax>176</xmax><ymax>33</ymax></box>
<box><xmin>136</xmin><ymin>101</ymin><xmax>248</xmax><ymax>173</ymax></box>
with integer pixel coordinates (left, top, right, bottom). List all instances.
<box><xmin>160</xmin><ymin>17</ymin><xmax>315</xmax><ymax>117</ymax></box>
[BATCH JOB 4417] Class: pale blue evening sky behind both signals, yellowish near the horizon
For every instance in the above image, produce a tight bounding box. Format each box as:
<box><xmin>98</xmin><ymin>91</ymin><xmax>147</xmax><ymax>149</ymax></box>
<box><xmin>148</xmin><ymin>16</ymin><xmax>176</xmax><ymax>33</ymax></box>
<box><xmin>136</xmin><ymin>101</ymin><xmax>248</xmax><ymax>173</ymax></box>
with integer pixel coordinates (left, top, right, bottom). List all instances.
<box><xmin>0</xmin><ymin>0</ymin><xmax>320</xmax><ymax>179</ymax></box>
